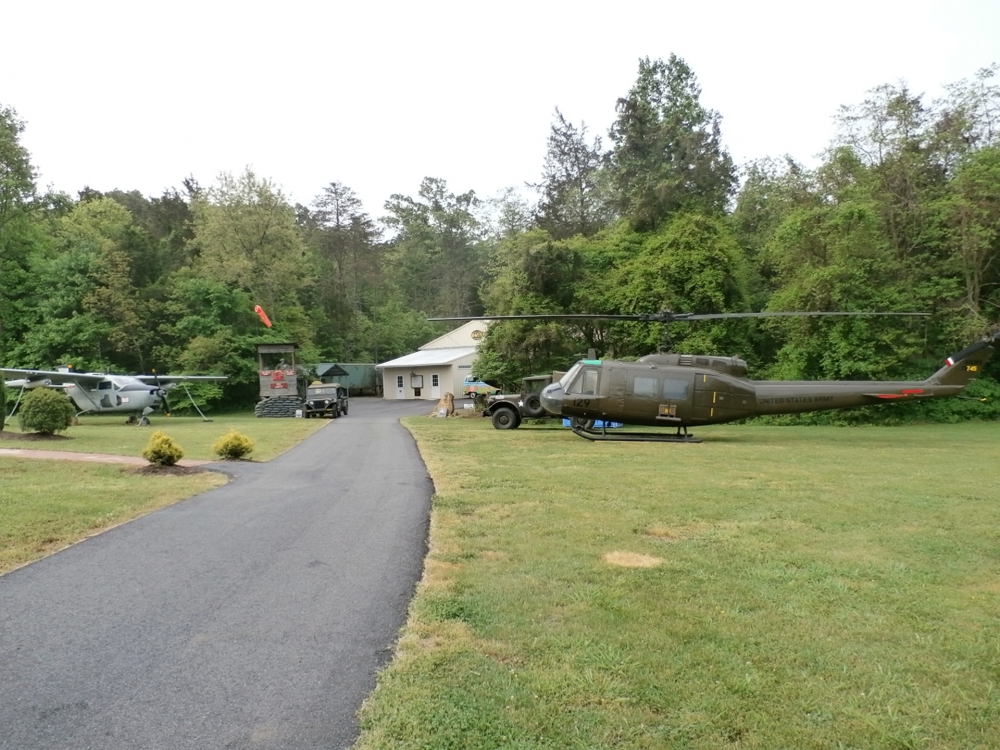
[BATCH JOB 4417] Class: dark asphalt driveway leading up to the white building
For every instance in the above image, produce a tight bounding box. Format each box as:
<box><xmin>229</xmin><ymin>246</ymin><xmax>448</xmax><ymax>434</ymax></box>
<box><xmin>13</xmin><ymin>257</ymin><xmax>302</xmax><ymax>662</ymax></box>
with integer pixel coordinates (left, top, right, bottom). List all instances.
<box><xmin>0</xmin><ymin>399</ymin><xmax>433</xmax><ymax>750</ymax></box>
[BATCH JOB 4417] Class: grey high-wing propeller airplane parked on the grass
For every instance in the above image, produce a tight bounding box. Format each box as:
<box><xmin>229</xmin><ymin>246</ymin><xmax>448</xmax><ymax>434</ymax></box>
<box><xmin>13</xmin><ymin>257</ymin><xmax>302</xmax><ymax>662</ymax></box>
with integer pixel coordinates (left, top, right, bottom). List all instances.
<box><xmin>0</xmin><ymin>367</ymin><xmax>226</xmax><ymax>426</ymax></box>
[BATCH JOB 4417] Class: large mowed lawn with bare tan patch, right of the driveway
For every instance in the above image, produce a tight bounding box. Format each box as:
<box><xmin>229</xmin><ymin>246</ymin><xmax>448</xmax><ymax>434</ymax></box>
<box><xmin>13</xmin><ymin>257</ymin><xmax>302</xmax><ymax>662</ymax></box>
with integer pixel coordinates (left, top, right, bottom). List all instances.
<box><xmin>358</xmin><ymin>418</ymin><xmax>1000</xmax><ymax>750</ymax></box>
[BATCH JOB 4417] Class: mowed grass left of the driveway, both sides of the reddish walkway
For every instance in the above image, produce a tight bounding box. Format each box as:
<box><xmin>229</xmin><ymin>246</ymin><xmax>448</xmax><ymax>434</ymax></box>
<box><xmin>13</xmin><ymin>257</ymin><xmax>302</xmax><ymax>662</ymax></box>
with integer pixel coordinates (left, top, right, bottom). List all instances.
<box><xmin>0</xmin><ymin>415</ymin><xmax>328</xmax><ymax>573</ymax></box>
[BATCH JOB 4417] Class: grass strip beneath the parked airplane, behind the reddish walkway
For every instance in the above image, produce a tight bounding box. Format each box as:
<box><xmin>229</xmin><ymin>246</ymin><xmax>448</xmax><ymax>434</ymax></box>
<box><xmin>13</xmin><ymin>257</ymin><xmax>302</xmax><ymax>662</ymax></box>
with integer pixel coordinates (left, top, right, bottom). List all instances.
<box><xmin>0</xmin><ymin>413</ymin><xmax>324</xmax><ymax>461</ymax></box>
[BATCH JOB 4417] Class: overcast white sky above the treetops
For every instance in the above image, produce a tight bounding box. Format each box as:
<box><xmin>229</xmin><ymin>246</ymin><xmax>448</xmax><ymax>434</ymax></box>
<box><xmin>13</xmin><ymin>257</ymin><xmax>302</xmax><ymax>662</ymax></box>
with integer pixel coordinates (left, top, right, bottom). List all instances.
<box><xmin>0</xmin><ymin>0</ymin><xmax>1000</xmax><ymax>216</ymax></box>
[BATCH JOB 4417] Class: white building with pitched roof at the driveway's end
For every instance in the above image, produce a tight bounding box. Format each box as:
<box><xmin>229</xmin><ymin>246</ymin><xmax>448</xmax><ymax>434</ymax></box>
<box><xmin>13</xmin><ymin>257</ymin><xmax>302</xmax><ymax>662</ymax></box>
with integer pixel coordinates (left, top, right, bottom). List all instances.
<box><xmin>377</xmin><ymin>320</ymin><xmax>489</xmax><ymax>401</ymax></box>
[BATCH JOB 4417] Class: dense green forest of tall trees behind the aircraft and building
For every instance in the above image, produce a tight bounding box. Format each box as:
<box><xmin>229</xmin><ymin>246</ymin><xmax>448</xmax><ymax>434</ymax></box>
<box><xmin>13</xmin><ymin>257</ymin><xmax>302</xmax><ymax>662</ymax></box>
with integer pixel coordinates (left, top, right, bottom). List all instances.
<box><xmin>0</xmin><ymin>56</ymin><xmax>1000</xmax><ymax>418</ymax></box>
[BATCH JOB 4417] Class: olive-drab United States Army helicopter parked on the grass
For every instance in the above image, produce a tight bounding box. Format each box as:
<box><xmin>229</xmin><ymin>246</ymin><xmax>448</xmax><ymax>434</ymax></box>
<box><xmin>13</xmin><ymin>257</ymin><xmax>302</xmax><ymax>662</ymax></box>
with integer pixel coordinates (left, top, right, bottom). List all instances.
<box><xmin>432</xmin><ymin>310</ymin><xmax>1000</xmax><ymax>443</ymax></box>
